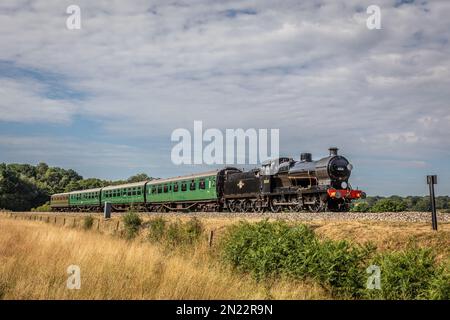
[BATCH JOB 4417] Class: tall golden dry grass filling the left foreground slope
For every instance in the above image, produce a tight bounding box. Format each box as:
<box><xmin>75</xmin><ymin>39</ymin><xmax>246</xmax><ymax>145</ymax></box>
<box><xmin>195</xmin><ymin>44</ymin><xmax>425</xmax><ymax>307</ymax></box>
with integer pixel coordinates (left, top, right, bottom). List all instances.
<box><xmin>0</xmin><ymin>216</ymin><xmax>327</xmax><ymax>299</ymax></box>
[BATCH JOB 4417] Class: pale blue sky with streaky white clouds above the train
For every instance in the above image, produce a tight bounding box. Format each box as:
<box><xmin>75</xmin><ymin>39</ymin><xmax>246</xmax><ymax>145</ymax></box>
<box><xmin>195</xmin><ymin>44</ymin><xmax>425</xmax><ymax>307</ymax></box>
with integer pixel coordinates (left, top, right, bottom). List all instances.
<box><xmin>0</xmin><ymin>0</ymin><xmax>450</xmax><ymax>195</ymax></box>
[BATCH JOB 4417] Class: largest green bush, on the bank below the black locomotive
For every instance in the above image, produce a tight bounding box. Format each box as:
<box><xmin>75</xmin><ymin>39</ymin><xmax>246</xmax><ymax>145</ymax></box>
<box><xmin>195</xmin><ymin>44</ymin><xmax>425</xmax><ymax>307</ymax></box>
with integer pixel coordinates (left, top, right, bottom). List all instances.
<box><xmin>221</xmin><ymin>220</ymin><xmax>375</xmax><ymax>297</ymax></box>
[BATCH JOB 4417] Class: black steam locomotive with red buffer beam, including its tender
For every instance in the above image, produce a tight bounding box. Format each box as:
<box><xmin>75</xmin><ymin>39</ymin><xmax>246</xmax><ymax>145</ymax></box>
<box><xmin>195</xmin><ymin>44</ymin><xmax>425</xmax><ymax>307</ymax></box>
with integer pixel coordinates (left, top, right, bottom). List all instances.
<box><xmin>219</xmin><ymin>148</ymin><xmax>365</xmax><ymax>212</ymax></box>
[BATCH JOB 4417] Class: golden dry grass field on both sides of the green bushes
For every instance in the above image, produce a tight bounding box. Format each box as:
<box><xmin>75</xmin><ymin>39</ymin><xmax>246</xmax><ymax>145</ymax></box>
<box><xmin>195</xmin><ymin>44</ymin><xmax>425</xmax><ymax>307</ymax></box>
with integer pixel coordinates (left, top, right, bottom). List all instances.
<box><xmin>0</xmin><ymin>213</ymin><xmax>450</xmax><ymax>299</ymax></box>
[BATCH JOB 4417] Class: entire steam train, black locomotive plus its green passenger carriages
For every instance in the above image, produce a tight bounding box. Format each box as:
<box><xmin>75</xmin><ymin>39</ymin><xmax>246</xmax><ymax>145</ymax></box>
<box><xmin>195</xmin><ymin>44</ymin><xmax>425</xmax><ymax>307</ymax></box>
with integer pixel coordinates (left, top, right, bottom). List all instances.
<box><xmin>50</xmin><ymin>148</ymin><xmax>365</xmax><ymax>212</ymax></box>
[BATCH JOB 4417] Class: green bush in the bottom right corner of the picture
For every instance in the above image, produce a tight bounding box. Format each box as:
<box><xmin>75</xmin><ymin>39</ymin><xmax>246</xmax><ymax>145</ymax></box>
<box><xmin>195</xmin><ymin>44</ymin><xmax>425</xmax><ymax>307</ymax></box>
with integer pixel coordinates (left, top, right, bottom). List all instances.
<box><xmin>366</xmin><ymin>247</ymin><xmax>450</xmax><ymax>300</ymax></box>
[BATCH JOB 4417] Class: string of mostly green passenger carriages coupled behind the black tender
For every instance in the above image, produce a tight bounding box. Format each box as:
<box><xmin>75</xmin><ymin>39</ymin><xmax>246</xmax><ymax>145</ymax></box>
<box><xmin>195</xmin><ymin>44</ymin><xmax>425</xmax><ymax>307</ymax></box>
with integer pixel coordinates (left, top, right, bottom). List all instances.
<box><xmin>50</xmin><ymin>170</ymin><xmax>227</xmax><ymax>212</ymax></box>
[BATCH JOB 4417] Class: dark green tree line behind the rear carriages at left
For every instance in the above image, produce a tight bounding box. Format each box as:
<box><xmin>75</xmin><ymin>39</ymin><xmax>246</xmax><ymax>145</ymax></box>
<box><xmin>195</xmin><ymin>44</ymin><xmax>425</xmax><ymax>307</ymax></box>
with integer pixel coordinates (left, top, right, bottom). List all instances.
<box><xmin>0</xmin><ymin>163</ymin><xmax>152</xmax><ymax>211</ymax></box>
